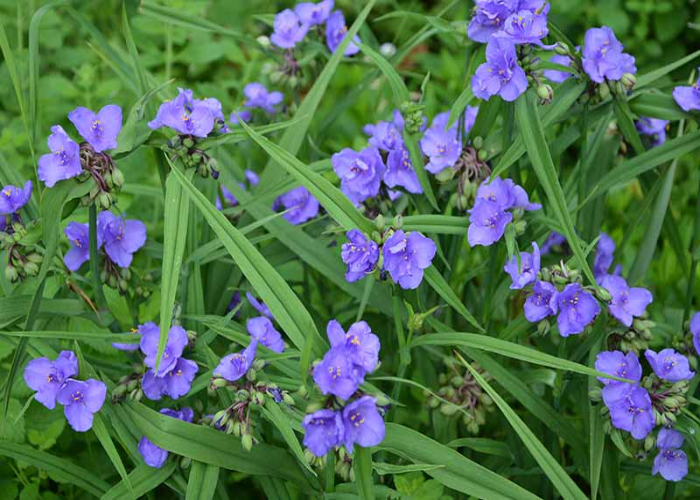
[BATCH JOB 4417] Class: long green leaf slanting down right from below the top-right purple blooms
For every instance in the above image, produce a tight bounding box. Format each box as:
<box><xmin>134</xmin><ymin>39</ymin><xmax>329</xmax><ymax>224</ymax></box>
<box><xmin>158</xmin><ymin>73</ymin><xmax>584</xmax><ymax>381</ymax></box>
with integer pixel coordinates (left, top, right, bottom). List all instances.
<box><xmin>515</xmin><ymin>92</ymin><xmax>596</xmax><ymax>285</ymax></box>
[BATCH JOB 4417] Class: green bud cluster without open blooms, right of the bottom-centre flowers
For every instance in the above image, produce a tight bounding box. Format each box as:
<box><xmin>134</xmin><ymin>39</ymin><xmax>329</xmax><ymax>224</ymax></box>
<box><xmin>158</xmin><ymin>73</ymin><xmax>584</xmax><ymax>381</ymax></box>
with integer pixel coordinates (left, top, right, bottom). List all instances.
<box><xmin>425</xmin><ymin>357</ymin><xmax>494</xmax><ymax>434</ymax></box>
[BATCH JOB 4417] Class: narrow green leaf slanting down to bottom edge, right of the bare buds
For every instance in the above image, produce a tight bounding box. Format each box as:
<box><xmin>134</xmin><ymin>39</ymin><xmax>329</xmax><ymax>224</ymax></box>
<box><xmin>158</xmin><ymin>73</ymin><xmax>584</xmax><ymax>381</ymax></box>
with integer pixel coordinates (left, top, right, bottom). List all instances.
<box><xmin>458</xmin><ymin>355</ymin><xmax>587</xmax><ymax>500</ymax></box>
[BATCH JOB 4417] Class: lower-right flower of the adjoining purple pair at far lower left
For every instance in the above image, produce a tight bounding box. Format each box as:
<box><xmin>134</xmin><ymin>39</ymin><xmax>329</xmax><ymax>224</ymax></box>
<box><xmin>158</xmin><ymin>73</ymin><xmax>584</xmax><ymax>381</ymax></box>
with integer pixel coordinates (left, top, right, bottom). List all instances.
<box><xmin>56</xmin><ymin>378</ymin><xmax>107</xmax><ymax>432</ymax></box>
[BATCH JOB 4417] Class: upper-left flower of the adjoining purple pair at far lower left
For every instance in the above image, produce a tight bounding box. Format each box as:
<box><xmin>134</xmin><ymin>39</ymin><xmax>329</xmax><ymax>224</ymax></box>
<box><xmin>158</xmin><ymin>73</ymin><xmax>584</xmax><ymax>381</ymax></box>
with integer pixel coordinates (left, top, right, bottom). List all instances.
<box><xmin>24</xmin><ymin>351</ymin><xmax>78</xmax><ymax>410</ymax></box>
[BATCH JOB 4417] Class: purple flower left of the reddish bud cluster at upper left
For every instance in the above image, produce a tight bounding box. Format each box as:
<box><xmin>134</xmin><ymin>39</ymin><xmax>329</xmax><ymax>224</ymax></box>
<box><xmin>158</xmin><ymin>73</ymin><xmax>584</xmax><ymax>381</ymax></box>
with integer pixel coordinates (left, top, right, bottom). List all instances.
<box><xmin>38</xmin><ymin>125</ymin><xmax>83</xmax><ymax>187</ymax></box>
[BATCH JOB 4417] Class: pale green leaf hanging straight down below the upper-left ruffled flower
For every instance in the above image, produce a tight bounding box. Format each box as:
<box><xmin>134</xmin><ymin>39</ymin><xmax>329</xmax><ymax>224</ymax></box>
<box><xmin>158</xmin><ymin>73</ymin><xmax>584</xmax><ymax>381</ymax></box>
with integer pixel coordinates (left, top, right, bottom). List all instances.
<box><xmin>156</xmin><ymin>170</ymin><xmax>192</xmax><ymax>372</ymax></box>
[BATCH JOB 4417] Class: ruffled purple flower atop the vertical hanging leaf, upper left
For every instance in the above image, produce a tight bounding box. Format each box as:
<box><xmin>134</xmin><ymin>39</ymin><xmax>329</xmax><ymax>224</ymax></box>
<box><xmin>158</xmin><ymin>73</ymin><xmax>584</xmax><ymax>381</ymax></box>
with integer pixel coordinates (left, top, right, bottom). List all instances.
<box><xmin>148</xmin><ymin>89</ymin><xmax>217</xmax><ymax>137</ymax></box>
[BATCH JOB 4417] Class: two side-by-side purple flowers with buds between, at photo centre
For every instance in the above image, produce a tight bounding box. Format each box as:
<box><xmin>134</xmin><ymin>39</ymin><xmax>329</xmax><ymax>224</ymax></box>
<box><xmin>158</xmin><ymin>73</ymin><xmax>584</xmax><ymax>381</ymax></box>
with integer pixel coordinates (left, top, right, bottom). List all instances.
<box><xmin>341</xmin><ymin>229</ymin><xmax>437</xmax><ymax>289</ymax></box>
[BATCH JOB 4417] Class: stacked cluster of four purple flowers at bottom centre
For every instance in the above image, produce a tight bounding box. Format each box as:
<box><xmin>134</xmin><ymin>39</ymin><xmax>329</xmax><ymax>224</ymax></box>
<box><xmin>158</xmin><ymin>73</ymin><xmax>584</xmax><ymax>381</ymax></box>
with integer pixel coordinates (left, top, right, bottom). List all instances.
<box><xmin>302</xmin><ymin>320</ymin><xmax>385</xmax><ymax>457</ymax></box>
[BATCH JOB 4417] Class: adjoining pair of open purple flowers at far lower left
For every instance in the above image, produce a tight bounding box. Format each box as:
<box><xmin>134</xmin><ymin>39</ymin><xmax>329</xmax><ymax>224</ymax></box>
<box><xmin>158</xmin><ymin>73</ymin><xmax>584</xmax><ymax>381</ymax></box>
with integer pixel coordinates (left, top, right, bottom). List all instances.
<box><xmin>24</xmin><ymin>351</ymin><xmax>107</xmax><ymax>432</ymax></box>
